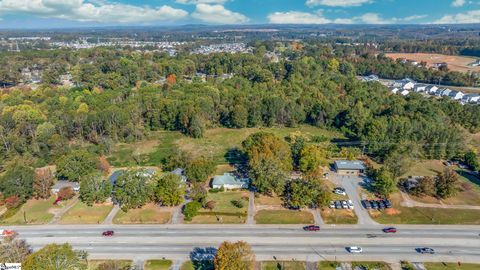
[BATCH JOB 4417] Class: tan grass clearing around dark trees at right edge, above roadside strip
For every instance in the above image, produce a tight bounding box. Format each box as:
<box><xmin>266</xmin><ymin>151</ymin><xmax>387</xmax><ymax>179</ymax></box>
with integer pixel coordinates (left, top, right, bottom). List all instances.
<box><xmin>402</xmin><ymin>160</ymin><xmax>480</xmax><ymax>205</ymax></box>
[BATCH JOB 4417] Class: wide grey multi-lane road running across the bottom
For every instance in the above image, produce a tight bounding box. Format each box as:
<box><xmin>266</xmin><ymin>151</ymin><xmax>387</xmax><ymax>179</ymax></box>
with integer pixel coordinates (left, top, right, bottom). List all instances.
<box><xmin>7</xmin><ymin>225</ymin><xmax>480</xmax><ymax>262</ymax></box>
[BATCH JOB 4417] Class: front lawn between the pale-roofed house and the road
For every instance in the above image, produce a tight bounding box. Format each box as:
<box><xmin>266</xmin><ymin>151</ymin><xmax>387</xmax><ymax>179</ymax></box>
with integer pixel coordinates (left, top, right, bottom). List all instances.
<box><xmin>188</xmin><ymin>191</ymin><xmax>248</xmax><ymax>224</ymax></box>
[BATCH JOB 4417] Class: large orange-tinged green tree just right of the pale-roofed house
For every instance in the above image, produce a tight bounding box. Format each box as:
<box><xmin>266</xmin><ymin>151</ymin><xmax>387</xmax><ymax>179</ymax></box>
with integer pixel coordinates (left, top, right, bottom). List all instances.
<box><xmin>243</xmin><ymin>132</ymin><xmax>292</xmax><ymax>194</ymax></box>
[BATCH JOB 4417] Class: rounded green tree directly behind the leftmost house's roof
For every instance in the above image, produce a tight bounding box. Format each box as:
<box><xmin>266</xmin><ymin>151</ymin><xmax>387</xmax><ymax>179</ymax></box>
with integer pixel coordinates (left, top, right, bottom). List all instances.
<box><xmin>57</xmin><ymin>150</ymin><xmax>98</xmax><ymax>181</ymax></box>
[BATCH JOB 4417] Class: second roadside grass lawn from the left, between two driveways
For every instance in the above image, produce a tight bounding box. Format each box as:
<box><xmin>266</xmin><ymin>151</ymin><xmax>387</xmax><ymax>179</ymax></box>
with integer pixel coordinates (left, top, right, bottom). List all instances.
<box><xmin>60</xmin><ymin>201</ymin><xmax>113</xmax><ymax>224</ymax></box>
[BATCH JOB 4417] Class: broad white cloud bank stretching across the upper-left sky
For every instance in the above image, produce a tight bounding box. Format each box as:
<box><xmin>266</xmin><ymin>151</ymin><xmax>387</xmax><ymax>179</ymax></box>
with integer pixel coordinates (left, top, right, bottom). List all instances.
<box><xmin>0</xmin><ymin>0</ymin><xmax>188</xmax><ymax>23</ymax></box>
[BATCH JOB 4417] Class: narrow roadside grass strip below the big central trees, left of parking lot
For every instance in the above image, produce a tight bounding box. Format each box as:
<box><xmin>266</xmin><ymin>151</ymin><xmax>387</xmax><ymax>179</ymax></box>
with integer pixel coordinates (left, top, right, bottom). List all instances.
<box><xmin>255</xmin><ymin>210</ymin><xmax>315</xmax><ymax>224</ymax></box>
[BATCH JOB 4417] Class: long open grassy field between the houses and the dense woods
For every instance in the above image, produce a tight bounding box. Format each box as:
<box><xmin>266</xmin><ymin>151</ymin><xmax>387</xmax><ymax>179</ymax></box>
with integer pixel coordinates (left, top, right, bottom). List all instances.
<box><xmin>108</xmin><ymin>126</ymin><xmax>344</xmax><ymax>167</ymax></box>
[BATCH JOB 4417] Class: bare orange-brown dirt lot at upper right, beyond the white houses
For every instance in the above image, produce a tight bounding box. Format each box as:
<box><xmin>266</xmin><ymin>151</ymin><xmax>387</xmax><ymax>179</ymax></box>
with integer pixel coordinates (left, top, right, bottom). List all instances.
<box><xmin>386</xmin><ymin>53</ymin><xmax>480</xmax><ymax>73</ymax></box>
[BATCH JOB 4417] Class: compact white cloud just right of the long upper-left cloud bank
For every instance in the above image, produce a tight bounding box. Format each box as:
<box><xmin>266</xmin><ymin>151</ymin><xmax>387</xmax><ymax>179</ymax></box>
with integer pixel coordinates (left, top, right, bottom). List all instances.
<box><xmin>192</xmin><ymin>4</ymin><xmax>249</xmax><ymax>24</ymax></box>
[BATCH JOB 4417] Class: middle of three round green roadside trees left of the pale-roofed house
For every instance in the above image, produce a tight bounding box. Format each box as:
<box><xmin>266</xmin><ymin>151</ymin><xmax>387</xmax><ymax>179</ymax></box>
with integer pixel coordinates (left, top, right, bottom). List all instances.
<box><xmin>113</xmin><ymin>169</ymin><xmax>153</xmax><ymax>212</ymax></box>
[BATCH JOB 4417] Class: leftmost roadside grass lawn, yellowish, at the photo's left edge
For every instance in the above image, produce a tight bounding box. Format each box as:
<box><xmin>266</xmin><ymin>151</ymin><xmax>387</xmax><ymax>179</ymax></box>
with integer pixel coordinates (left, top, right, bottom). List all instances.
<box><xmin>0</xmin><ymin>196</ymin><xmax>75</xmax><ymax>225</ymax></box>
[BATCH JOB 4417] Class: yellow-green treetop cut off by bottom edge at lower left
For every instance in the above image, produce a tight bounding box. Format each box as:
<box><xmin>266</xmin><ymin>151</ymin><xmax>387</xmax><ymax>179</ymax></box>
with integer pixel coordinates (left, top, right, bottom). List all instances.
<box><xmin>22</xmin><ymin>244</ymin><xmax>87</xmax><ymax>270</ymax></box>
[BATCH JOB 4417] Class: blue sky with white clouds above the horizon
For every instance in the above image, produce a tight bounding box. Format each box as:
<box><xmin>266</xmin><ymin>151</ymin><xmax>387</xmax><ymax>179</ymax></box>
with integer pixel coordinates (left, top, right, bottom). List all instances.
<box><xmin>0</xmin><ymin>0</ymin><xmax>480</xmax><ymax>28</ymax></box>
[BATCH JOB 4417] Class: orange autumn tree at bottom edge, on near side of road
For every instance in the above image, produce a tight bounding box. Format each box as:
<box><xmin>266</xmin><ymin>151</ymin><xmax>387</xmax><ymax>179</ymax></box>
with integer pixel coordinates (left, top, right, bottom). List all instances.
<box><xmin>214</xmin><ymin>241</ymin><xmax>255</xmax><ymax>270</ymax></box>
